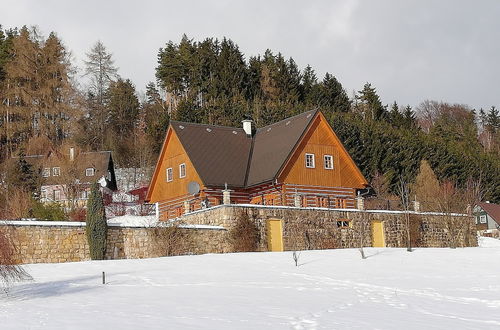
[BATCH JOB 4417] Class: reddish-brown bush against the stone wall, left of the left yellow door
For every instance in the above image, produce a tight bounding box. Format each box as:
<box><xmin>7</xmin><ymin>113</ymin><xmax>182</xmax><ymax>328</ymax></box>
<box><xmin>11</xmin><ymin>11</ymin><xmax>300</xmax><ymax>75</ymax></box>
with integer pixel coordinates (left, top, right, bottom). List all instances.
<box><xmin>229</xmin><ymin>211</ymin><xmax>260</xmax><ymax>252</ymax></box>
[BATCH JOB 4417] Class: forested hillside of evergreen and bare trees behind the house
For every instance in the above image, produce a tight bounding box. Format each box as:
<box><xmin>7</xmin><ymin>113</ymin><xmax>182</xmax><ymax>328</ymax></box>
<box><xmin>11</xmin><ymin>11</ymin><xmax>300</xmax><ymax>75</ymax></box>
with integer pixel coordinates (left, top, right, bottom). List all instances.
<box><xmin>0</xmin><ymin>27</ymin><xmax>500</xmax><ymax>202</ymax></box>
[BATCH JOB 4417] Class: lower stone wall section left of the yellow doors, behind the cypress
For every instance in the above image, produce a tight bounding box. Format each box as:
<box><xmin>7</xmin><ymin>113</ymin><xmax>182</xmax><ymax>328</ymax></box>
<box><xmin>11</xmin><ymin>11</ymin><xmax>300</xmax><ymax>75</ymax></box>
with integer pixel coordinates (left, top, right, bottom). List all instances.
<box><xmin>0</xmin><ymin>221</ymin><xmax>229</xmax><ymax>264</ymax></box>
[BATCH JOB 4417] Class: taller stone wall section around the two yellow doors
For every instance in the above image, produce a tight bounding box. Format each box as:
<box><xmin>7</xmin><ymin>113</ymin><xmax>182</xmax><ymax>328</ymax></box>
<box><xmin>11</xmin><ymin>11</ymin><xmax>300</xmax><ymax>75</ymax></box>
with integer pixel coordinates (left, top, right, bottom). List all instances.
<box><xmin>182</xmin><ymin>205</ymin><xmax>477</xmax><ymax>251</ymax></box>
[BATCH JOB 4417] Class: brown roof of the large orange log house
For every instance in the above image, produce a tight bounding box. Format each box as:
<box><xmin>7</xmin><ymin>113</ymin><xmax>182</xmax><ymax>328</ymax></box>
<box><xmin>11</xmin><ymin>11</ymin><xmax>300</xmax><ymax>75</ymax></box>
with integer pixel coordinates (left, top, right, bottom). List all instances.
<box><xmin>171</xmin><ymin>110</ymin><xmax>317</xmax><ymax>187</ymax></box>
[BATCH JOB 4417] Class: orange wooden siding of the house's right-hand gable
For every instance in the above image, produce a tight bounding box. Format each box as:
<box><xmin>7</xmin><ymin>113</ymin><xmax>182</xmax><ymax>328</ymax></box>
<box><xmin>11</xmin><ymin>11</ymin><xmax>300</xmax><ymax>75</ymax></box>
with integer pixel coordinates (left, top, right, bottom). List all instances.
<box><xmin>278</xmin><ymin>114</ymin><xmax>367</xmax><ymax>189</ymax></box>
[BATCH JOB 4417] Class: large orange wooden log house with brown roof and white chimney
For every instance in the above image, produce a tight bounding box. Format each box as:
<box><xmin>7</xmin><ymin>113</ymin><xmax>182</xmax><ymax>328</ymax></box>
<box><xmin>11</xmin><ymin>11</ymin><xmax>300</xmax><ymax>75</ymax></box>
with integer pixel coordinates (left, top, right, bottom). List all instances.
<box><xmin>146</xmin><ymin>110</ymin><xmax>368</xmax><ymax>219</ymax></box>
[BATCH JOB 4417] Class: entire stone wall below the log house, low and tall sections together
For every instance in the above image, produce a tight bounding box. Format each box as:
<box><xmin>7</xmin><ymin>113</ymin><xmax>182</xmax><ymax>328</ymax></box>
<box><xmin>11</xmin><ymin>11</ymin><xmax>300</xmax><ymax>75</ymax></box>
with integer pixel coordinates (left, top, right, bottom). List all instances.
<box><xmin>0</xmin><ymin>205</ymin><xmax>477</xmax><ymax>263</ymax></box>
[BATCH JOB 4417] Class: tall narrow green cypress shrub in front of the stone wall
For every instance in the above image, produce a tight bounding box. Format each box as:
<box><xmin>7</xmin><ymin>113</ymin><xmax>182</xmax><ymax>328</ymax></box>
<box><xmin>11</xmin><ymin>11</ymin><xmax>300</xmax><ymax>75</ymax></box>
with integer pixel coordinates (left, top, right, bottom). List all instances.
<box><xmin>85</xmin><ymin>182</ymin><xmax>108</xmax><ymax>260</ymax></box>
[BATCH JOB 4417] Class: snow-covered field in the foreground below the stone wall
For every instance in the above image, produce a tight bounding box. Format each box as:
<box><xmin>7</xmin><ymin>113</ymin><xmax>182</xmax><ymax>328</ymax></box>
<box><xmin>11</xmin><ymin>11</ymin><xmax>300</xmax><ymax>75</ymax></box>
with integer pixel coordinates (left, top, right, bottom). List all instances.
<box><xmin>0</xmin><ymin>239</ymin><xmax>500</xmax><ymax>330</ymax></box>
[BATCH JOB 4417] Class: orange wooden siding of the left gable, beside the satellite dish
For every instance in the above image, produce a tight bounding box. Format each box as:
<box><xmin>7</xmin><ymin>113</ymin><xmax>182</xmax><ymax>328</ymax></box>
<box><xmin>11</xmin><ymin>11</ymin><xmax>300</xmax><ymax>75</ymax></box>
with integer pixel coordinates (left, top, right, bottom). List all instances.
<box><xmin>148</xmin><ymin>128</ymin><xmax>203</xmax><ymax>203</ymax></box>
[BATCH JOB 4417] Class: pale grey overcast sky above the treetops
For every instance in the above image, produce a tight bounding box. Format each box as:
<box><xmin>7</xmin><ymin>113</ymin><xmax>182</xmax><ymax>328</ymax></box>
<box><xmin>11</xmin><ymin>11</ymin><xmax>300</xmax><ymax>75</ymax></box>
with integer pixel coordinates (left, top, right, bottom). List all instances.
<box><xmin>0</xmin><ymin>0</ymin><xmax>500</xmax><ymax>109</ymax></box>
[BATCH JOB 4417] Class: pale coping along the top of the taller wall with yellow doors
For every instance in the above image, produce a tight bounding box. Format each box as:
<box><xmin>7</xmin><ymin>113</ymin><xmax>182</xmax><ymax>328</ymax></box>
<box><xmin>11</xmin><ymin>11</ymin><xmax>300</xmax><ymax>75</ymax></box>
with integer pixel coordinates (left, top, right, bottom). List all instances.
<box><xmin>180</xmin><ymin>204</ymin><xmax>469</xmax><ymax>219</ymax></box>
